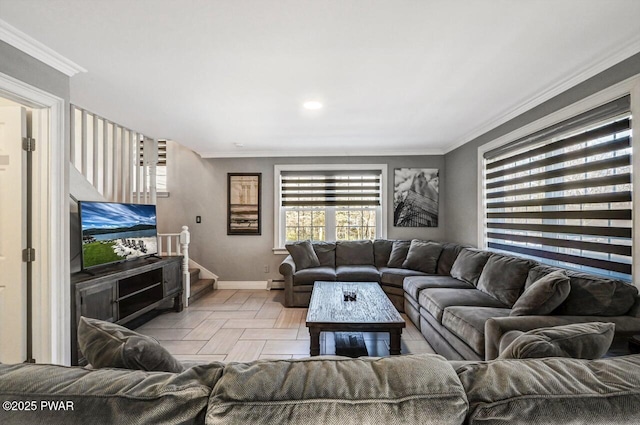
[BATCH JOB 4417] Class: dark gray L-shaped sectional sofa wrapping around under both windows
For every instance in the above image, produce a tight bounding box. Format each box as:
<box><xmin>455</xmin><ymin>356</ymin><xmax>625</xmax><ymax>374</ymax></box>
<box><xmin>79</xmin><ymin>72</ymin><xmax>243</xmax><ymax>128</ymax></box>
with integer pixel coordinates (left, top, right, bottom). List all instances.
<box><xmin>280</xmin><ymin>240</ymin><xmax>640</xmax><ymax>360</ymax></box>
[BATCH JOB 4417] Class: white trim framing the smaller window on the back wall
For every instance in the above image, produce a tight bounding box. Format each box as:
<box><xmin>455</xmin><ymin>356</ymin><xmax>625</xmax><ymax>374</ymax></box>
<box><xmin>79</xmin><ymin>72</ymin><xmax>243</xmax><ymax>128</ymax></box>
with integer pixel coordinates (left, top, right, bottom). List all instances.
<box><xmin>273</xmin><ymin>164</ymin><xmax>389</xmax><ymax>255</ymax></box>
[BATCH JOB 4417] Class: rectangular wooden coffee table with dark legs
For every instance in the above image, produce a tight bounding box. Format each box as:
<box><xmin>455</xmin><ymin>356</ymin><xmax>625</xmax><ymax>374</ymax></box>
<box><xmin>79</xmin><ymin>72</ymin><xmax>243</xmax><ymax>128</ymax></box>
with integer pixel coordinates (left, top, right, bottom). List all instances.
<box><xmin>307</xmin><ymin>281</ymin><xmax>406</xmax><ymax>356</ymax></box>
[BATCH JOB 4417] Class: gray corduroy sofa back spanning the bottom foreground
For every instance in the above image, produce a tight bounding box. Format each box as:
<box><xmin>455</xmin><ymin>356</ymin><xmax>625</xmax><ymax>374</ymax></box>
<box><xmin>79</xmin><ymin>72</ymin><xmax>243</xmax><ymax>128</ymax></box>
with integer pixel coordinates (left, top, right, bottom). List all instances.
<box><xmin>0</xmin><ymin>355</ymin><xmax>640</xmax><ymax>425</ymax></box>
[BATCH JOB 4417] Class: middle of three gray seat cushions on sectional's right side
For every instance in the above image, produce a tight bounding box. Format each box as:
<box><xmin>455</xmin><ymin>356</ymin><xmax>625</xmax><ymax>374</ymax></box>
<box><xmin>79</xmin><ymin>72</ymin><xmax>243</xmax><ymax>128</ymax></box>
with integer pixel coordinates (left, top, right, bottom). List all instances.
<box><xmin>418</xmin><ymin>288</ymin><xmax>506</xmax><ymax>322</ymax></box>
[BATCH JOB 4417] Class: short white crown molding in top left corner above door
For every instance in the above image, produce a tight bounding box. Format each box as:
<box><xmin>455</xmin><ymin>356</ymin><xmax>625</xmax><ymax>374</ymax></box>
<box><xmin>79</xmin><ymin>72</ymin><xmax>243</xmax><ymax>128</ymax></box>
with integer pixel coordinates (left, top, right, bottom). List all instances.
<box><xmin>0</xmin><ymin>19</ymin><xmax>87</xmax><ymax>77</ymax></box>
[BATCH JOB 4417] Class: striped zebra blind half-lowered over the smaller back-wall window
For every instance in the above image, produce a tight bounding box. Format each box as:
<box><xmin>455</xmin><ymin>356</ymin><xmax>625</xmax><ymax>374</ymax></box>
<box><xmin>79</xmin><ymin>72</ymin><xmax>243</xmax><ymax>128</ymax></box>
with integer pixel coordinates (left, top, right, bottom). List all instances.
<box><xmin>281</xmin><ymin>172</ymin><xmax>380</xmax><ymax>207</ymax></box>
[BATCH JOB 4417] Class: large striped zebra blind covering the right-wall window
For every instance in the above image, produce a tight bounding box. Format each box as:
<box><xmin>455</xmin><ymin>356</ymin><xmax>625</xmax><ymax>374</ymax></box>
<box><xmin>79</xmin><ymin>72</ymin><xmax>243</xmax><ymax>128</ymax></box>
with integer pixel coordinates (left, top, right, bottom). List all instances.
<box><xmin>485</xmin><ymin>97</ymin><xmax>633</xmax><ymax>280</ymax></box>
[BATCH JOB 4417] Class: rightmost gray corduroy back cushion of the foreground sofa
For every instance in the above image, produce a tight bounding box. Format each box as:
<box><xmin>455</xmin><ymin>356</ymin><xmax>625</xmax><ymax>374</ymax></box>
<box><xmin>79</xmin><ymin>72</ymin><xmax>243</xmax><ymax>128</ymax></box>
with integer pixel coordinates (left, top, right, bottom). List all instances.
<box><xmin>456</xmin><ymin>356</ymin><xmax>640</xmax><ymax>425</ymax></box>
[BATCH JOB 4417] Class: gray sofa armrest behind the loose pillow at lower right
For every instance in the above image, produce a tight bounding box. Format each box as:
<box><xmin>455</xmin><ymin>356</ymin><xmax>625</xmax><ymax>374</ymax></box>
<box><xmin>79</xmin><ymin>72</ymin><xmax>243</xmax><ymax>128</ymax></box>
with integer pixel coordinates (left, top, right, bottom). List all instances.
<box><xmin>484</xmin><ymin>316</ymin><xmax>640</xmax><ymax>360</ymax></box>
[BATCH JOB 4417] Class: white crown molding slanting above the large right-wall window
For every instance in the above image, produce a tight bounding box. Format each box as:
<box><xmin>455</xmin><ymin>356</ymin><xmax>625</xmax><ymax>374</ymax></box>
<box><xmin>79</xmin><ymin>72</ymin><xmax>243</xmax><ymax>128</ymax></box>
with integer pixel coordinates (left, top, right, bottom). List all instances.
<box><xmin>443</xmin><ymin>35</ymin><xmax>640</xmax><ymax>154</ymax></box>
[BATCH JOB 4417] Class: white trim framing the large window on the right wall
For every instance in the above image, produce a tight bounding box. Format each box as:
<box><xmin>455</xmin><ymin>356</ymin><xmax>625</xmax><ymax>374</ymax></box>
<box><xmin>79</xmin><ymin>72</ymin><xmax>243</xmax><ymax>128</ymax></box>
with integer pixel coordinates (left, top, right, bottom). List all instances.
<box><xmin>477</xmin><ymin>74</ymin><xmax>640</xmax><ymax>287</ymax></box>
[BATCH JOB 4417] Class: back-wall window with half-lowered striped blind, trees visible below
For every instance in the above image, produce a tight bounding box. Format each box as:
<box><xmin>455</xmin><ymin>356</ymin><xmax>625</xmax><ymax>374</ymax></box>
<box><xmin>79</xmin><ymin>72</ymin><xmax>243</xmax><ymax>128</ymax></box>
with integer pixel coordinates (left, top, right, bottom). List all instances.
<box><xmin>275</xmin><ymin>165</ymin><xmax>386</xmax><ymax>249</ymax></box>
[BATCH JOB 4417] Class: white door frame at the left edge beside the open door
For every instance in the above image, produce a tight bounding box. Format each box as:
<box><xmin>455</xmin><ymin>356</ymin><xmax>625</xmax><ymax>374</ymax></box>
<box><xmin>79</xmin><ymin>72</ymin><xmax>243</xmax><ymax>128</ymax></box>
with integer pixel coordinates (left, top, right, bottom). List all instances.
<box><xmin>0</xmin><ymin>73</ymin><xmax>71</xmax><ymax>365</ymax></box>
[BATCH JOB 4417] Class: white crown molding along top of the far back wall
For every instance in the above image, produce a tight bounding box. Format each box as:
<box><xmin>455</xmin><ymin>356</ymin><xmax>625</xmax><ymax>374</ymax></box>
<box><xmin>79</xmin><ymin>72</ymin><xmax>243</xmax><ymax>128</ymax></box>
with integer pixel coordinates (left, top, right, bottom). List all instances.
<box><xmin>196</xmin><ymin>149</ymin><xmax>445</xmax><ymax>158</ymax></box>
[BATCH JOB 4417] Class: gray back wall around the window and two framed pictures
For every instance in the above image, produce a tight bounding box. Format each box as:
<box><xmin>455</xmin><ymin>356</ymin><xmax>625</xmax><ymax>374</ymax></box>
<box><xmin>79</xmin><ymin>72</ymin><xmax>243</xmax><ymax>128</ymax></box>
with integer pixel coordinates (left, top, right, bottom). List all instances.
<box><xmin>158</xmin><ymin>143</ymin><xmax>447</xmax><ymax>281</ymax></box>
